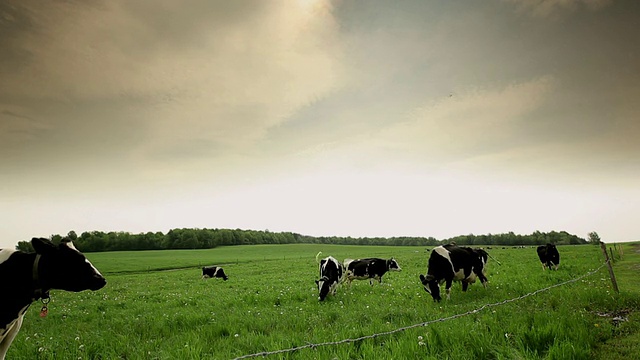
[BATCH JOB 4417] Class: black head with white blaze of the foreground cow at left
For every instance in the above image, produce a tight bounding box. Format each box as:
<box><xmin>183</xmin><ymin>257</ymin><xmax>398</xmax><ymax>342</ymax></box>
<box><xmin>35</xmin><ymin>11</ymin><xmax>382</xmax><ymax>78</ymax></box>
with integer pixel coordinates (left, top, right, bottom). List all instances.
<box><xmin>31</xmin><ymin>238</ymin><xmax>107</xmax><ymax>292</ymax></box>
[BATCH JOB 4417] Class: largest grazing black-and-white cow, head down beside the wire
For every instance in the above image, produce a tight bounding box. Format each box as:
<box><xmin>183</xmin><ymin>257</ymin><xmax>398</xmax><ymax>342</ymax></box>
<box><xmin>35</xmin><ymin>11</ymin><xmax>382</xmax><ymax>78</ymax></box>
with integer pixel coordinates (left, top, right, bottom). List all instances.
<box><xmin>420</xmin><ymin>244</ymin><xmax>489</xmax><ymax>301</ymax></box>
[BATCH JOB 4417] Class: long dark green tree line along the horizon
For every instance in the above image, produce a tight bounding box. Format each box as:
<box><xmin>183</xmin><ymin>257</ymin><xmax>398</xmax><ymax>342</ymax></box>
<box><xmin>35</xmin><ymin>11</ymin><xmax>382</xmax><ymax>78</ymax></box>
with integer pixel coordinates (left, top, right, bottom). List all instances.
<box><xmin>16</xmin><ymin>229</ymin><xmax>591</xmax><ymax>252</ymax></box>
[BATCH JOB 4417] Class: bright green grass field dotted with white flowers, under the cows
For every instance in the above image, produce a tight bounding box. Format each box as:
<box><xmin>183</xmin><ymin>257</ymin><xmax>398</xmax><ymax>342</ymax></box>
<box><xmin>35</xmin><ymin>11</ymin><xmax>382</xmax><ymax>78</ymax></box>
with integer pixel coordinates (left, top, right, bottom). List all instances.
<box><xmin>7</xmin><ymin>244</ymin><xmax>640</xmax><ymax>359</ymax></box>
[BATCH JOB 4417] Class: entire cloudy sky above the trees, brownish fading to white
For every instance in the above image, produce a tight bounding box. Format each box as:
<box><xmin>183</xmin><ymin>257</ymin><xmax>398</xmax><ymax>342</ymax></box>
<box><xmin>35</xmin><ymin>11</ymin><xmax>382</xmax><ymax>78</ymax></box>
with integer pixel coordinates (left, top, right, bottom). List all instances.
<box><xmin>0</xmin><ymin>0</ymin><xmax>640</xmax><ymax>247</ymax></box>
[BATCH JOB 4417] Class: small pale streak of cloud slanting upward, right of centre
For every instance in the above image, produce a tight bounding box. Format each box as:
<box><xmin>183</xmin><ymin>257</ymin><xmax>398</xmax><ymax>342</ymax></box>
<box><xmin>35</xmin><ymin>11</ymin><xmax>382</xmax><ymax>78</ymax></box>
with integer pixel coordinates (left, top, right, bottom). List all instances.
<box><xmin>378</xmin><ymin>77</ymin><xmax>556</xmax><ymax>161</ymax></box>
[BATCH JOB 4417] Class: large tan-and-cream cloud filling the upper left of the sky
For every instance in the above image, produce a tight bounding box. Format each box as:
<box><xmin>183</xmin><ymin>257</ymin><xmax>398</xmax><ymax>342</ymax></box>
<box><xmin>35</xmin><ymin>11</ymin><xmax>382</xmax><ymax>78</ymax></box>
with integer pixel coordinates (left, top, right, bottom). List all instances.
<box><xmin>0</xmin><ymin>0</ymin><xmax>343</xmax><ymax>179</ymax></box>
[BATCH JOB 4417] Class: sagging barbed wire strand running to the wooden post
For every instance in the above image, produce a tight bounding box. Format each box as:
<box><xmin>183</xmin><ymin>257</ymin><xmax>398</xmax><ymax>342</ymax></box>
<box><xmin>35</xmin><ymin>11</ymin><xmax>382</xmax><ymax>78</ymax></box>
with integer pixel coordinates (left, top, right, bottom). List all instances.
<box><xmin>232</xmin><ymin>259</ymin><xmax>611</xmax><ymax>360</ymax></box>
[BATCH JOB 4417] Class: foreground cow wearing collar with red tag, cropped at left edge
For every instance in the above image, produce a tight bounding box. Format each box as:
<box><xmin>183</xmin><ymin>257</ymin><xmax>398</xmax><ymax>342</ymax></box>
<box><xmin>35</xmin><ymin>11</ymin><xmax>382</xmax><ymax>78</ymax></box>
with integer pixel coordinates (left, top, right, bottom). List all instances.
<box><xmin>0</xmin><ymin>238</ymin><xmax>107</xmax><ymax>360</ymax></box>
